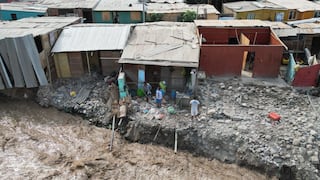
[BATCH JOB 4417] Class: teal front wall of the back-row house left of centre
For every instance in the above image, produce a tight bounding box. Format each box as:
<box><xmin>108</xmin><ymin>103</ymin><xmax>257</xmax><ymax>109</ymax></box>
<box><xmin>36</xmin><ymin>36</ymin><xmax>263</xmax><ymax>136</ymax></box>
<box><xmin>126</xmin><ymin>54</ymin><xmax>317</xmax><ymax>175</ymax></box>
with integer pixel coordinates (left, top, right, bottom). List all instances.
<box><xmin>93</xmin><ymin>11</ymin><xmax>142</xmax><ymax>24</ymax></box>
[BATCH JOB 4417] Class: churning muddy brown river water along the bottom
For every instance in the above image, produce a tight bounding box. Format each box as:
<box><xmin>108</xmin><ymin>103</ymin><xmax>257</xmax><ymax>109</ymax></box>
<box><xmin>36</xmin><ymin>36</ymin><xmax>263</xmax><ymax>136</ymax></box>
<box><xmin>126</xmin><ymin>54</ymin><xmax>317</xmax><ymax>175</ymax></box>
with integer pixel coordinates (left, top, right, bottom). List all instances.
<box><xmin>0</xmin><ymin>97</ymin><xmax>267</xmax><ymax>180</ymax></box>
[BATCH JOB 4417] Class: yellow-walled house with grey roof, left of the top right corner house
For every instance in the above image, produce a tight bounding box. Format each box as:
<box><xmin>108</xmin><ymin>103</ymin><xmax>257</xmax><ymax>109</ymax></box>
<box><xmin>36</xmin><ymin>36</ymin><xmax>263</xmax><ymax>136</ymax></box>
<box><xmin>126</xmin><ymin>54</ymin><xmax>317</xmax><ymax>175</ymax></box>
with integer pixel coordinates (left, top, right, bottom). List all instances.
<box><xmin>223</xmin><ymin>1</ymin><xmax>287</xmax><ymax>21</ymax></box>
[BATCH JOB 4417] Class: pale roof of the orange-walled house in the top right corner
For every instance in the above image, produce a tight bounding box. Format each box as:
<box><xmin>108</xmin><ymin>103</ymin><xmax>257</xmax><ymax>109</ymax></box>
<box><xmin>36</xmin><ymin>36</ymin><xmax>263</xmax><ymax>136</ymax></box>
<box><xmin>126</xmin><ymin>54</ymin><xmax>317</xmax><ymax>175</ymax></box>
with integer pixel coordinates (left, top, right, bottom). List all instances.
<box><xmin>266</xmin><ymin>0</ymin><xmax>320</xmax><ymax>12</ymax></box>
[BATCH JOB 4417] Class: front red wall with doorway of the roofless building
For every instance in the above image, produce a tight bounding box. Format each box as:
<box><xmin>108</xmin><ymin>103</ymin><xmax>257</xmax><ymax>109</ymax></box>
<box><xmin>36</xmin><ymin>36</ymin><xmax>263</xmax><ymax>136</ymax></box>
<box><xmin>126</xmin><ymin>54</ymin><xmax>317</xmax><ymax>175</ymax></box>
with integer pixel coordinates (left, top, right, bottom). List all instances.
<box><xmin>199</xmin><ymin>45</ymin><xmax>283</xmax><ymax>77</ymax></box>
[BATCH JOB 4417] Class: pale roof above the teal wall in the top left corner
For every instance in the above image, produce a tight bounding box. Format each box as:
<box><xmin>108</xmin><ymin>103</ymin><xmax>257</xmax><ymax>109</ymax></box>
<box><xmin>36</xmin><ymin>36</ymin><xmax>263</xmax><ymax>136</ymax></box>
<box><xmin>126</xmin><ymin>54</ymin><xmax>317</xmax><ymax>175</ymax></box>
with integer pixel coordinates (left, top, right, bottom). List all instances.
<box><xmin>0</xmin><ymin>2</ymin><xmax>48</xmax><ymax>13</ymax></box>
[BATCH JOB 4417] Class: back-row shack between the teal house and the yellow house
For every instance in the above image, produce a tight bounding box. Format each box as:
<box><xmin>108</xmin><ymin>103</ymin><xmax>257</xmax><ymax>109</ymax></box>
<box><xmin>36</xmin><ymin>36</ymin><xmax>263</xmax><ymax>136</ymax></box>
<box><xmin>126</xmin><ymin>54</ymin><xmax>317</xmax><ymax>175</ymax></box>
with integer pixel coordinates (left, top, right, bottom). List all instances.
<box><xmin>146</xmin><ymin>2</ymin><xmax>220</xmax><ymax>21</ymax></box>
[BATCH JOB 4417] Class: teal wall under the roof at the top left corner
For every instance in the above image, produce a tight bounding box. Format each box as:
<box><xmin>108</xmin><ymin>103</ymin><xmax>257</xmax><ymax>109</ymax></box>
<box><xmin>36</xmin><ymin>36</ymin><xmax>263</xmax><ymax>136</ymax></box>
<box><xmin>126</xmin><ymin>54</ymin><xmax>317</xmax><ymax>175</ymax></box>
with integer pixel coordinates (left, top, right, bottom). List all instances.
<box><xmin>0</xmin><ymin>10</ymin><xmax>46</xmax><ymax>21</ymax></box>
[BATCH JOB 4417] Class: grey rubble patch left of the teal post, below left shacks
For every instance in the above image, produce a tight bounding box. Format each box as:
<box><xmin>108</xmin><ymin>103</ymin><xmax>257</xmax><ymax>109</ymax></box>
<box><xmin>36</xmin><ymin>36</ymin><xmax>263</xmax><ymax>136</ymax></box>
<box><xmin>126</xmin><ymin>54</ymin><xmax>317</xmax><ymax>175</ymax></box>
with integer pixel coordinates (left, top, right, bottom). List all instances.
<box><xmin>37</xmin><ymin>75</ymin><xmax>117</xmax><ymax>126</ymax></box>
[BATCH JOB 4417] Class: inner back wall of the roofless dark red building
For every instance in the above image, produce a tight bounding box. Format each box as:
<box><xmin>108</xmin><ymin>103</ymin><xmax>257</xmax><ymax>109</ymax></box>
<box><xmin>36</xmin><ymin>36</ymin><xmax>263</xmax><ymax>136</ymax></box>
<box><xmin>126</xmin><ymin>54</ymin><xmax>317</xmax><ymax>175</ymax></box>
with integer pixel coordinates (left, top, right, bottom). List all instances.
<box><xmin>199</xmin><ymin>27</ymin><xmax>271</xmax><ymax>44</ymax></box>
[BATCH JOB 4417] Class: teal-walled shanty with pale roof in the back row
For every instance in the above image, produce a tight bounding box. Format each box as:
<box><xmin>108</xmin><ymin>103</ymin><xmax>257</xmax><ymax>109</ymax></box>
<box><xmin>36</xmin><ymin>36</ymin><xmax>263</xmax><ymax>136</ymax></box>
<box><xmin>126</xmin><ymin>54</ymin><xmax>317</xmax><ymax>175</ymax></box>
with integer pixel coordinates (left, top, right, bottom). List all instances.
<box><xmin>93</xmin><ymin>0</ymin><xmax>144</xmax><ymax>24</ymax></box>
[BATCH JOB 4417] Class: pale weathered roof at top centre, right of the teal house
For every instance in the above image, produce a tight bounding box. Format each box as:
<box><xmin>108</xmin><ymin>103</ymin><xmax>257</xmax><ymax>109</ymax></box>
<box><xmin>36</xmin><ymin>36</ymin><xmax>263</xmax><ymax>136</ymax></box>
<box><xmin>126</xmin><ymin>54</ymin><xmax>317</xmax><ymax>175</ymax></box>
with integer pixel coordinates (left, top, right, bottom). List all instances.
<box><xmin>146</xmin><ymin>3</ymin><xmax>220</xmax><ymax>14</ymax></box>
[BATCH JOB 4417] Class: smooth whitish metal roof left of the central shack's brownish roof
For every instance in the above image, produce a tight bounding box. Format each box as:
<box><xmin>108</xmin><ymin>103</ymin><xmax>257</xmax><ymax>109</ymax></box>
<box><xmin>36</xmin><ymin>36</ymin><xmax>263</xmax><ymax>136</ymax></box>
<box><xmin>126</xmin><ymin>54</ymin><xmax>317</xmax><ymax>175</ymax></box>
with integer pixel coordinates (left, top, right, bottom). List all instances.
<box><xmin>51</xmin><ymin>24</ymin><xmax>131</xmax><ymax>53</ymax></box>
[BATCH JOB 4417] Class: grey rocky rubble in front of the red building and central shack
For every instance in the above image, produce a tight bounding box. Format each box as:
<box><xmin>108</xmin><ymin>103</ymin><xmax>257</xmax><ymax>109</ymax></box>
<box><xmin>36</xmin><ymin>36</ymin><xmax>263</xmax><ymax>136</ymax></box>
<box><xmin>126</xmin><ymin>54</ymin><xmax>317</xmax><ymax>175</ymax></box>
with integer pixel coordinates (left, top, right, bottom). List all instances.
<box><xmin>126</xmin><ymin>79</ymin><xmax>320</xmax><ymax>179</ymax></box>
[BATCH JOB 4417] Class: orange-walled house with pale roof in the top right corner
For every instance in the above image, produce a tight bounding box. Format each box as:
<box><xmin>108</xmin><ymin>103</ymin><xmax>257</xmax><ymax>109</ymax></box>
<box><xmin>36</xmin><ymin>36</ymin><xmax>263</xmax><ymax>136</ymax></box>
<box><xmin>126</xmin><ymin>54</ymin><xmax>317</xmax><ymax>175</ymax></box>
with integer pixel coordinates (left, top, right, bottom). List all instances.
<box><xmin>266</xmin><ymin>0</ymin><xmax>320</xmax><ymax>21</ymax></box>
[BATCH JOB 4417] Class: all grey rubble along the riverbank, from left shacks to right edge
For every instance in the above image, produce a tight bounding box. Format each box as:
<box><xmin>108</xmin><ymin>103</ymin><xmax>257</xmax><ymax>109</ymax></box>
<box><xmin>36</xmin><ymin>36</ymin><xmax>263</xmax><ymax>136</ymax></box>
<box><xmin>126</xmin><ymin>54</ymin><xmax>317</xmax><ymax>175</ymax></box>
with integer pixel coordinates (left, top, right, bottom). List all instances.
<box><xmin>38</xmin><ymin>76</ymin><xmax>320</xmax><ymax>179</ymax></box>
